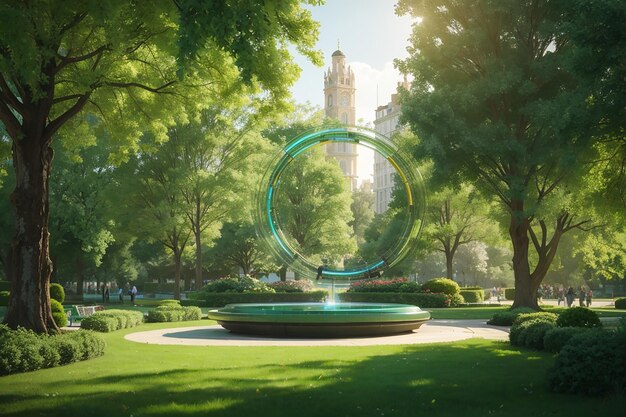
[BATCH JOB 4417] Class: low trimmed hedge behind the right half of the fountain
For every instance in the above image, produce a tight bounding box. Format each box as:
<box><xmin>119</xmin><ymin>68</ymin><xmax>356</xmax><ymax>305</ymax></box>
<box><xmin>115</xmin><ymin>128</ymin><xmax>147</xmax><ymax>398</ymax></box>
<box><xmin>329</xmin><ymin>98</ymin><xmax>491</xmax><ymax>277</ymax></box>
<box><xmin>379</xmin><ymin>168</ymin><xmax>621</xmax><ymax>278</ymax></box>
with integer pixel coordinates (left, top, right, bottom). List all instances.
<box><xmin>339</xmin><ymin>292</ymin><xmax>460</xmax><ymax>308</ymax></box>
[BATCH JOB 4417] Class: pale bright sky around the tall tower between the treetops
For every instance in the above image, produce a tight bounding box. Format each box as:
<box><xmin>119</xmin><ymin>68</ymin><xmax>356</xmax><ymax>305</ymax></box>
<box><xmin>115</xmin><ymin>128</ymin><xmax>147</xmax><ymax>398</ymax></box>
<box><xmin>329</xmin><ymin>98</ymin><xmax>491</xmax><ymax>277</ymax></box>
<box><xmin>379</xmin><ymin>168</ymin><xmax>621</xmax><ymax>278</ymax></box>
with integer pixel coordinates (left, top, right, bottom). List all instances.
<box><xmin>291</xmin><ymin>0</ymin><xmax>413</xmax><ymax>183</ymax></box>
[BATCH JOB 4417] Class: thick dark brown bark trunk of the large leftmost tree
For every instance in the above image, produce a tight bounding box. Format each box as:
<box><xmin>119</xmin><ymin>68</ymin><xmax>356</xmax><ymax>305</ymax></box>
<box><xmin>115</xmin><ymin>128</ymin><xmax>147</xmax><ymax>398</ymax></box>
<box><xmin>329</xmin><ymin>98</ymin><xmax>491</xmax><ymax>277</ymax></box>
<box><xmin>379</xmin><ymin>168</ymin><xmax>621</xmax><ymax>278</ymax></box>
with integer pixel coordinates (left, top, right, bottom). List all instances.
<box><xmin>4</xmin><ymin>139</ymin><xmax>59</xmax><ymax>333</ymax></box>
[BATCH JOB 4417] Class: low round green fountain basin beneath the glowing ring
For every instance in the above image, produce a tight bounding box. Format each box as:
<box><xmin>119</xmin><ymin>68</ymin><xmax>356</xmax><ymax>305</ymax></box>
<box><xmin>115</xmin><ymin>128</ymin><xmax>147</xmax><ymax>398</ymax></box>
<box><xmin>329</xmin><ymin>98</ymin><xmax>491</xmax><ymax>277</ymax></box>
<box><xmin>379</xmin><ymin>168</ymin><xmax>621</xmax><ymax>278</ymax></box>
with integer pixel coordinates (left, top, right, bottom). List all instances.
<box><xmin>208</xmin><ymin>303</ymin><xmax>430</xmax><ymax>338</ymax></box>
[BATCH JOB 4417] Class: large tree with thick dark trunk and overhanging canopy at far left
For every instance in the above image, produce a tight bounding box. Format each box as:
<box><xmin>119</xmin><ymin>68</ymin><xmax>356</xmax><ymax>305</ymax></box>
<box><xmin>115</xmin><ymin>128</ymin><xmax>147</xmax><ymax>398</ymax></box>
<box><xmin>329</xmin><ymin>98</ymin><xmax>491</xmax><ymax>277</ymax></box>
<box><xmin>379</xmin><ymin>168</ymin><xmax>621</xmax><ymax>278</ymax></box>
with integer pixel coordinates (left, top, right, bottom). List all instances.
<box><xmin>0</xmin><ymin>0</ymin><xmax>319</xmax><ymax>332</ymax></box>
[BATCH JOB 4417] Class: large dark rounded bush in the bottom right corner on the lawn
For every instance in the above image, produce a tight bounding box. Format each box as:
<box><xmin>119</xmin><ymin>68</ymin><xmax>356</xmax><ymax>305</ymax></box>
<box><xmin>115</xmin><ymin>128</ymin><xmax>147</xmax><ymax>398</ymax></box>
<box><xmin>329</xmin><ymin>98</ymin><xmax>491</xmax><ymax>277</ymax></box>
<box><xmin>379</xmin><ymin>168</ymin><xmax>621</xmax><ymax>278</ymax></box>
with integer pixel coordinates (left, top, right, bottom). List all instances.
<box><xmin>548</xmin><ymin>329</ymin><xmax>626</xmax><ymax>396</ymax></box>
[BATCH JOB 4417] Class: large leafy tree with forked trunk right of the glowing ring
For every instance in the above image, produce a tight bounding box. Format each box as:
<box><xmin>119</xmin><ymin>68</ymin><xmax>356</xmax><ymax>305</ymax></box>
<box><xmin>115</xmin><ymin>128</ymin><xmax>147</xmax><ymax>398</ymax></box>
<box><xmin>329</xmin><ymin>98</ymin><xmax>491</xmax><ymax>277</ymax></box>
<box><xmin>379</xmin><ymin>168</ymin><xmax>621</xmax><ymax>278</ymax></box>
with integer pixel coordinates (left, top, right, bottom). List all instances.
<box><xmin>399</xmin><ymin>0</ymin><xmax>597</xmax><ymax>308</ymax></box>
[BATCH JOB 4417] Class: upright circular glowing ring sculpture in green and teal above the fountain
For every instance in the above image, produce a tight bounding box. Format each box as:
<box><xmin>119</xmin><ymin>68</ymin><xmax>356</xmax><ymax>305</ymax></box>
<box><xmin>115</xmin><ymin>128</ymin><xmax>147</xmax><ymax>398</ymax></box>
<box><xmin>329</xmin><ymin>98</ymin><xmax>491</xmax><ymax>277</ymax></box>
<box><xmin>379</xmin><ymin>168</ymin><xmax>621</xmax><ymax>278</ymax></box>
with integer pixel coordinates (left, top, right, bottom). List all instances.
<box><xmin>256</xmin><ymin>126</ymin><xmax>426</xmax><ymax>278</ymax></box>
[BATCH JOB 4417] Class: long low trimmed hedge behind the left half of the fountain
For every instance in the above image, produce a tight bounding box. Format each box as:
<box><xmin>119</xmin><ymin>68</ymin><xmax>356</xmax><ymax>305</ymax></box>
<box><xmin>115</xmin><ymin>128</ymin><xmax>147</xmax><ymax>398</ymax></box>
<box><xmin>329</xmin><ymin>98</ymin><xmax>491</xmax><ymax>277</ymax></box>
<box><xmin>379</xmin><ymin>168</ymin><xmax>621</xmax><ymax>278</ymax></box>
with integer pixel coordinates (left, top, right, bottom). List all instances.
<box><xmin>185</xmin><ymin>291</ymin><xmax>328</xmax><ymax>307</ymax></box>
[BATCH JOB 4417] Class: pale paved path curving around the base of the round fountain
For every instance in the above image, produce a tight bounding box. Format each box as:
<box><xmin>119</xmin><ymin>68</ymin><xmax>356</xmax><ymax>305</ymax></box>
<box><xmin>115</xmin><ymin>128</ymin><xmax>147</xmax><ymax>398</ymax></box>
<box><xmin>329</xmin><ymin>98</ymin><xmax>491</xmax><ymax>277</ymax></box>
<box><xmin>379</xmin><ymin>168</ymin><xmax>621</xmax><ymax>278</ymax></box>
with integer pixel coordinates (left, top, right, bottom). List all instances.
<box><xmin>125</xmin><ymin>320</ymin><xmax>509</xmax><ymax>346</ymax></box>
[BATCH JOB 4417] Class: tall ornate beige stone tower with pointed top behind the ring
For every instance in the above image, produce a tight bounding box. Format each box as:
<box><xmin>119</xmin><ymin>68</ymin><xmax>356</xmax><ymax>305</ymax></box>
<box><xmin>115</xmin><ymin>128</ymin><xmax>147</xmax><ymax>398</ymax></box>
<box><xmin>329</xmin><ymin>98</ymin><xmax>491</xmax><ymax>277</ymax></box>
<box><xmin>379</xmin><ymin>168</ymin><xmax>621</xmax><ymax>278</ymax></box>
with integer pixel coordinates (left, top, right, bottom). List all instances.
<box><xmin>324</xmin><ymin>49</ymin><xmax>357</xmax><ymax>191</ymax></box>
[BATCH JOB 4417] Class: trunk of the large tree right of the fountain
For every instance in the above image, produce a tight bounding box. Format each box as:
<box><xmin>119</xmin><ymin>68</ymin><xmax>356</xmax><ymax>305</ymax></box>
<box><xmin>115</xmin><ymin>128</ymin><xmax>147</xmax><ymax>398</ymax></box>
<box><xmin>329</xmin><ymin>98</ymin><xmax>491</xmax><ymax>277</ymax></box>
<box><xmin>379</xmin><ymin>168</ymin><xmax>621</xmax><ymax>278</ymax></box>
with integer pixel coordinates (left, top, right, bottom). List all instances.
<box><xmin>509</xmin><ymin>202</ymin><xmax>541</xmax><ymax>310</ymax></box>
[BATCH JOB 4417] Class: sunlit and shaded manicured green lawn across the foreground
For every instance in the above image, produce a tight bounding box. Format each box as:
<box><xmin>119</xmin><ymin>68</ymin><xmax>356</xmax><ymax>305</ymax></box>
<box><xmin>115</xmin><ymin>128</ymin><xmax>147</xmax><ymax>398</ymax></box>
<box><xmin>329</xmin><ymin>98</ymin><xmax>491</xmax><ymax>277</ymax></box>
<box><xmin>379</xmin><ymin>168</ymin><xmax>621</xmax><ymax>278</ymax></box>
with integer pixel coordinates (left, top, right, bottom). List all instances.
<box><xmin>0</xmin><ymin>320</ymin><xmax>626</xmax><ymax>417</ymax></box>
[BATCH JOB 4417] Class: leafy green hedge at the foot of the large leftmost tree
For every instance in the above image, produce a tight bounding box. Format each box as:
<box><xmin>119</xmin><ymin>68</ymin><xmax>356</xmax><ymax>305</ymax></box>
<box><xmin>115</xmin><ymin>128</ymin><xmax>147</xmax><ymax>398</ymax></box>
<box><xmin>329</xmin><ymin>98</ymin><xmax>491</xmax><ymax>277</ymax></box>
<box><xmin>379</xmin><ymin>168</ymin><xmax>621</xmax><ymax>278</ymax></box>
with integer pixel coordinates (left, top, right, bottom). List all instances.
<box><xmin>0</xmin><ymin>324</ymin><xmax>106</xmax><ymax>375</ymax></box>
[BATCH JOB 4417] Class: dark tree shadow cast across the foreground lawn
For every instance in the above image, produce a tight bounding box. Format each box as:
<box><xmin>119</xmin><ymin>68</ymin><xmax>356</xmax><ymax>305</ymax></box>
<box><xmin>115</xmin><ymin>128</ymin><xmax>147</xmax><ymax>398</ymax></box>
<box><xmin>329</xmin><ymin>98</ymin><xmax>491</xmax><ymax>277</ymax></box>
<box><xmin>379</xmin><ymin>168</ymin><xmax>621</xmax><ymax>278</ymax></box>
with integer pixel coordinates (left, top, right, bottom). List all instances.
<box><xmin>0</xmin><ymin>340</ymin><xmax>624</xmax><ymax>417</ymax></box>
